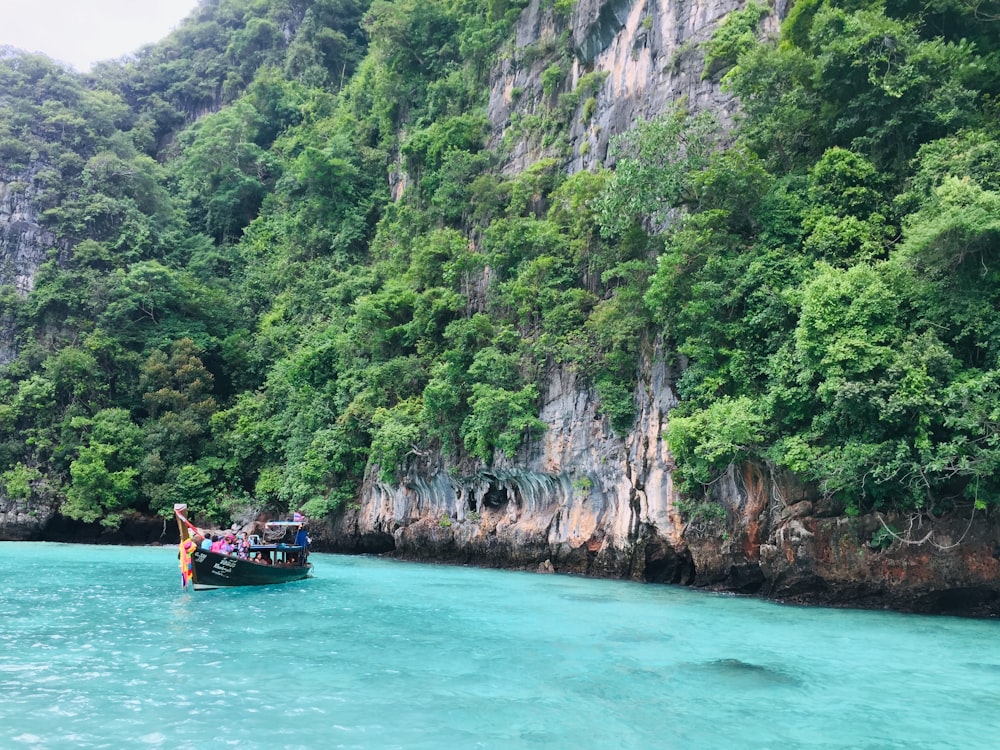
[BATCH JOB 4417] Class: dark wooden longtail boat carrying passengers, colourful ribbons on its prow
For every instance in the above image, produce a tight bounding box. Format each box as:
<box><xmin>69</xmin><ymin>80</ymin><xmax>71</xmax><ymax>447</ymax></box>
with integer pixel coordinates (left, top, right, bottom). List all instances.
<box><xmin>174</xmin><ymin>504</ymin><xmax>312</xmax><ymax>591</ymax></box>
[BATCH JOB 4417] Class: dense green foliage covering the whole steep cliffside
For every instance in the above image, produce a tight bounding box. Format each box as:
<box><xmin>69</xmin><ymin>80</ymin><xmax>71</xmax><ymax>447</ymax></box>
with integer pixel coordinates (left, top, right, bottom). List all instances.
<box><xmin>0</xmin><ymin>0</ymin><xmax>1000</xmax><ymax>525</ymax></box>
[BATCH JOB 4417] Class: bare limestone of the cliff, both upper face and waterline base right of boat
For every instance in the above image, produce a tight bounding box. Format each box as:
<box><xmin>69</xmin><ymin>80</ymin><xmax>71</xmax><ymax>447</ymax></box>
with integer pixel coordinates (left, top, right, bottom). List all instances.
<box><xmin>316</xmin><ymin>0</ymin><xmax>1000</xmax><ymax>614</ymax></box>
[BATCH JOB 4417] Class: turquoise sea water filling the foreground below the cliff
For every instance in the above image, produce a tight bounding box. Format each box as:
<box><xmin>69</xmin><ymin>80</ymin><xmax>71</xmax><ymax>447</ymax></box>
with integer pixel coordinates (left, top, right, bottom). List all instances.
<box><xmin>0</xmin><ymin>543</ymin><xmax>1000</xmax><ymax>750</ymax></box>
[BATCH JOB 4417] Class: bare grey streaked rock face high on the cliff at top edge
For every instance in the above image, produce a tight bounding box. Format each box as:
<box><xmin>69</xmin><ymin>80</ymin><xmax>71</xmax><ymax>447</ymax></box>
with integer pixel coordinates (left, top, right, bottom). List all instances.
<box><xmin>489</xmin><ymin>0</ymin><xmax>768</xmax><ymax>172</ymax></box>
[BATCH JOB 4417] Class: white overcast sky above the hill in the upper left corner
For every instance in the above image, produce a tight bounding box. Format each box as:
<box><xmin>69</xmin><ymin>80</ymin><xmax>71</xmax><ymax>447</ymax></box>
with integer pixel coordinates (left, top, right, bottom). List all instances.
<box><xmin>0</xmin><ymin>0</ymin><xmax>198</xmax><ymax>73</ymax></box>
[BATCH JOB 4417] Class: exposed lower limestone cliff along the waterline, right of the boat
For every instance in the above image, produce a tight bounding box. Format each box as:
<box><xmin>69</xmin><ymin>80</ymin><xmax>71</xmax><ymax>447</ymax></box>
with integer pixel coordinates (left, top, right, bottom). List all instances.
<box><xmin>330</xmin><ymin>336</ymin><xmax>1000</xmax><ymax>615</ymax></box>
